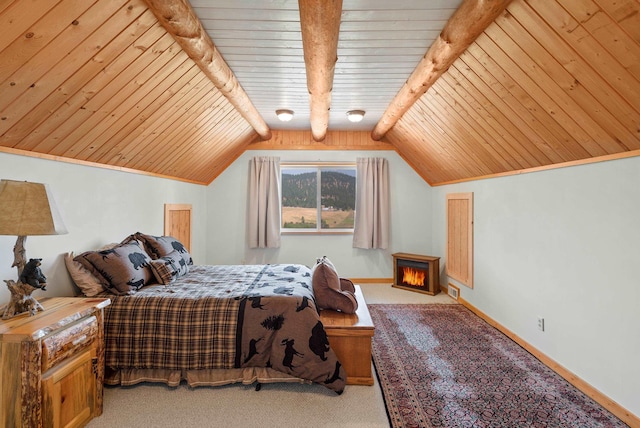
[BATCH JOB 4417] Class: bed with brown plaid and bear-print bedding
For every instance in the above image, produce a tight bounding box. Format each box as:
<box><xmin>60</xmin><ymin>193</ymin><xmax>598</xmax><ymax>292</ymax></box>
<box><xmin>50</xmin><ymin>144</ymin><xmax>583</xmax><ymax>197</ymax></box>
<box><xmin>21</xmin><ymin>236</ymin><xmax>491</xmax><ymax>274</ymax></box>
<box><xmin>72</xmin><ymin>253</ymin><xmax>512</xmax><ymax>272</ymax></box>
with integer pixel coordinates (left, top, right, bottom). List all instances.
<box><xmin>67</xmin><ymin>237</ymin><xmax>346</xmax><ymax>394</ymax></box>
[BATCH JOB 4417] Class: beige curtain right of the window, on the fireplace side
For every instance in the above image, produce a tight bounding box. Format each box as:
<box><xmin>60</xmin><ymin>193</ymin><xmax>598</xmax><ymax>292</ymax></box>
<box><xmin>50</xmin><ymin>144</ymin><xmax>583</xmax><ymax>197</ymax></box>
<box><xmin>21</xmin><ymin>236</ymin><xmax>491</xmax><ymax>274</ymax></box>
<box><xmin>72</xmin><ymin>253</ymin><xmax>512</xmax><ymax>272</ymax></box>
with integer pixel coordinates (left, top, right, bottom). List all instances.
<box><xmin>353</xmin><ymin>158</ymin><xmax>389</xmax><ymax>249</ymax></box>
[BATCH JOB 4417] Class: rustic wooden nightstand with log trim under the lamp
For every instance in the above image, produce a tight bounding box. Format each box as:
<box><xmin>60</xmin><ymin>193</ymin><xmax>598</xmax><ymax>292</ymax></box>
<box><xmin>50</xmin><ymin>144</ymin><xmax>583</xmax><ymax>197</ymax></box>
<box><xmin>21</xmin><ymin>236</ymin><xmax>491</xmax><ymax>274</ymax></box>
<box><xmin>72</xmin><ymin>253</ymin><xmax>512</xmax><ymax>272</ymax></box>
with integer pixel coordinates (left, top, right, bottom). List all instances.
<box><xmin>0</xmin><ymin>297</ymin><xmax>111</xmax><ymax>427</ymax></box>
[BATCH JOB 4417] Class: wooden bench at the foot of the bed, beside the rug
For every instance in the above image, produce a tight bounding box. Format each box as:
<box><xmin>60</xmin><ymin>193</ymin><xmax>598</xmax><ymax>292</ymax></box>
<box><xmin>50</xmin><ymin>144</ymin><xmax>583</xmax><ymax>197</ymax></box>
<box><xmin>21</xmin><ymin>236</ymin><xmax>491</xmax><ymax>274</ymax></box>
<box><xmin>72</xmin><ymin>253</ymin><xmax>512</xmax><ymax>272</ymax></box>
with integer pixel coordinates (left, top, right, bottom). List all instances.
<box><xmin>320</xmin><ymin>285</ymin><xmax>374</xmax><ymax>385</ymax></box>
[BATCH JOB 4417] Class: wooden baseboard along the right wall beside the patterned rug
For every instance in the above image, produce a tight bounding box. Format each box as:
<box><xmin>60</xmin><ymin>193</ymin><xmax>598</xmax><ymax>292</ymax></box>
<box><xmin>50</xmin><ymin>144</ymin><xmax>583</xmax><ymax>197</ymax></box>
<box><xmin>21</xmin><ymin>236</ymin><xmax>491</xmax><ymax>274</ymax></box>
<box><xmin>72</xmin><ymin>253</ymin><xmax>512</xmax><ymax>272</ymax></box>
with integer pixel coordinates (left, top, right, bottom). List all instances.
<box><xmin>458</xmin><ymin>297</ymin><xmax>640</xmax><ymax>428</ymax></box>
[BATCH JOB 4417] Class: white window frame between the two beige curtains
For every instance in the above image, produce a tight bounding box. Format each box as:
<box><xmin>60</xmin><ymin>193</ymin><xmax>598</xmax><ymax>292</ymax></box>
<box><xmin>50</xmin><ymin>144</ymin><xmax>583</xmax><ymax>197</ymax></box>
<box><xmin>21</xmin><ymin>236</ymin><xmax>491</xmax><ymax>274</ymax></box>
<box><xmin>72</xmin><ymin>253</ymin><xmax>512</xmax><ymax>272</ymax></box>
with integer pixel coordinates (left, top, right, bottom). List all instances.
<box><xmin>280</xmin><ymin>162</ymin><xmax>358</xmax><ymax>235</ymax></box>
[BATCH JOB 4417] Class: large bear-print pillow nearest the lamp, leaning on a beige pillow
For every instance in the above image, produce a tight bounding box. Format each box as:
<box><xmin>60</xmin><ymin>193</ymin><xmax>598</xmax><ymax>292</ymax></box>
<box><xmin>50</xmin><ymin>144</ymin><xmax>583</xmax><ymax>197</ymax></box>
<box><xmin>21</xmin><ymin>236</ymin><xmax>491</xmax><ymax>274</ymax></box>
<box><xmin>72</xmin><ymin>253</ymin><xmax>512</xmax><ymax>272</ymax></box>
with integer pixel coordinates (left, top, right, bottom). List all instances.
<box><xmin>74</xmin><ymin>241</ymin><xmax>155</xmax><ymax>294</ymax></box>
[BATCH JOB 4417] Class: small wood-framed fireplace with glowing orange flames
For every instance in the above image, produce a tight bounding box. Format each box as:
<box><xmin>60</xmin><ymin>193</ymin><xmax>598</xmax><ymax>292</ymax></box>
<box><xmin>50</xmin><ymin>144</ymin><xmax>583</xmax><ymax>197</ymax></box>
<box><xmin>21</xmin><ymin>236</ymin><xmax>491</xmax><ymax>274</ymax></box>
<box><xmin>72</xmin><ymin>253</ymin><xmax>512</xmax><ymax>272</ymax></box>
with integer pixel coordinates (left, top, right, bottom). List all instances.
<box><xmin>393</xmin><ymin>253</ymin><xmax>440</xmax><ymax>295</ymax></box>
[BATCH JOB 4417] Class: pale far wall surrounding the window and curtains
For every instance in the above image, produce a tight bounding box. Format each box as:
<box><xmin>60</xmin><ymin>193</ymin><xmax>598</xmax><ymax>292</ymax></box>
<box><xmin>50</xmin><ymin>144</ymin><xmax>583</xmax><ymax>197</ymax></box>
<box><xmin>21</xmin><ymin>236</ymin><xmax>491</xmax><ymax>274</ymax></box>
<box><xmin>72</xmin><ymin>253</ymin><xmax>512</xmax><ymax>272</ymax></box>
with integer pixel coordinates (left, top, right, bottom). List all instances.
<box><xmin>207</xmin><ymin>150</ymin><xmax>432</xmax><ymax>278</ymax></box>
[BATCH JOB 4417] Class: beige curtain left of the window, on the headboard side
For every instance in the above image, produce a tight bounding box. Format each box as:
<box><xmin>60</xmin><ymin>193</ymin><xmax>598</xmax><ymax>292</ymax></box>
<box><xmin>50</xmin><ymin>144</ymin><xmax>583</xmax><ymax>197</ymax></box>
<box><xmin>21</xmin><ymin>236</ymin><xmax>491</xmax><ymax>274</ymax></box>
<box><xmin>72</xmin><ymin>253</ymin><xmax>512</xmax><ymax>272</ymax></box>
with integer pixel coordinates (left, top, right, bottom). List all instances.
<box><xmin>248</xmin><ymin>156</ymin><xmax>280</xmax><ymax>248</ymax></box>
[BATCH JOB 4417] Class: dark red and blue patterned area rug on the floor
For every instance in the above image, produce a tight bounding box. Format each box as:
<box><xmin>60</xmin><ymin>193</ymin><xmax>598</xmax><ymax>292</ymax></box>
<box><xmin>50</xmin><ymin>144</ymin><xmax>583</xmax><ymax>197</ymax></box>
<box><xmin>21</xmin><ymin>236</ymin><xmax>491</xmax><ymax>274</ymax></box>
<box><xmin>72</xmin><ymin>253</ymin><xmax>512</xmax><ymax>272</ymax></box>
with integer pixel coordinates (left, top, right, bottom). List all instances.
<box><xmin>369</xmin><ymin>305</ymin><xmax>627</xmax><ymax>428</ymax></box>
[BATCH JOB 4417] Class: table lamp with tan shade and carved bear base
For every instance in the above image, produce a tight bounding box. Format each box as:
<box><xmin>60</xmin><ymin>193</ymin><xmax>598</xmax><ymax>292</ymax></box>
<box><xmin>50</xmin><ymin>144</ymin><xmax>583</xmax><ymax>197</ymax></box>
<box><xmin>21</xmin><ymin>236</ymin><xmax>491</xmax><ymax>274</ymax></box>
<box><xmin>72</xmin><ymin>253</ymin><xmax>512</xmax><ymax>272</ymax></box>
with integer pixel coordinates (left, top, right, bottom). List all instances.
<box><xmin>0</xmin><ymin>180</ymin><xmax>67</xmax><ymax>319</ymax></box>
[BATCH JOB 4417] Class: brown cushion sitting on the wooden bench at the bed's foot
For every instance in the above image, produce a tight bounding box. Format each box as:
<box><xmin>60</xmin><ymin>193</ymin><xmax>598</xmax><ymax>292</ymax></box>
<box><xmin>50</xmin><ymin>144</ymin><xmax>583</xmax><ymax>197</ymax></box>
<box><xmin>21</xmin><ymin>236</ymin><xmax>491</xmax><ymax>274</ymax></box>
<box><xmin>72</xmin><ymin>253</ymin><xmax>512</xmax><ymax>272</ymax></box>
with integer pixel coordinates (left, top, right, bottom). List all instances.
<box><xmin>311</xmin><ymin>256</ymin><xmax>358</xmax><ymax>314</ymax></box>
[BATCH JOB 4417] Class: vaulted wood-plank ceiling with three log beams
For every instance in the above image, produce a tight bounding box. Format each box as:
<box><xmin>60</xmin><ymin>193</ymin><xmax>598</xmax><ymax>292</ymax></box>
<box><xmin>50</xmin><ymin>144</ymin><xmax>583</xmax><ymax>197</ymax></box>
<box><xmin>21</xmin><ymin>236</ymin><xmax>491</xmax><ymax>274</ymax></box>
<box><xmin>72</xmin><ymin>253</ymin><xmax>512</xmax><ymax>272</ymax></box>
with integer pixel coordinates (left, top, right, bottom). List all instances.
<box><xmin>0</xmin><ymin>0</ymin><xmax>640</xmax><ymax>184</ymax></box>
